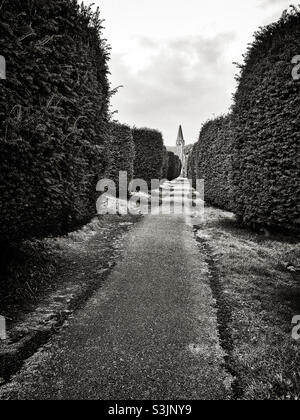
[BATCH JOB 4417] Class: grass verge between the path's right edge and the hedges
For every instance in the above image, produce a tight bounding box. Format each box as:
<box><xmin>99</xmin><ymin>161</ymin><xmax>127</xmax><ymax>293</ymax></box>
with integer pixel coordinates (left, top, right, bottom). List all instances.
<box><xmin>196</xmin><ymin>208</ymin><xmax>300</xmax><ymax>400</ymax></box>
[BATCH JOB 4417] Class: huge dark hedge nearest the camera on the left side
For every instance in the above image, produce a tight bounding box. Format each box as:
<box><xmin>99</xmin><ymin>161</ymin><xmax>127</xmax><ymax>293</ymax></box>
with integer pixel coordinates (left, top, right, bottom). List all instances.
<box><xmin>0</xmin><ymin>0</ymin><xmax>110</xmax><ymax>243</ymax></box>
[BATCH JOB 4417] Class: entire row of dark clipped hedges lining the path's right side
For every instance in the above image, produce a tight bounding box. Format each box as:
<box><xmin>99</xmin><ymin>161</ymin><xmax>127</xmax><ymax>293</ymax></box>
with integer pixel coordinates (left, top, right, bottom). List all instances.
<box><xmin>188</xmin><ymin>8</ymin><xmax>300</xmax><ymax>231</ymax></box>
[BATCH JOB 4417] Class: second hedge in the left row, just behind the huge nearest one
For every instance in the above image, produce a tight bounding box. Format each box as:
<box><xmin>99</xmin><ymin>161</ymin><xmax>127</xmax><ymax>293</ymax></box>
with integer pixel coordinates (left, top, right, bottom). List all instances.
<box><xmin>105</xmin><ymin>122</ymin><xmax>135</xmax><ymax>191</ymax></box>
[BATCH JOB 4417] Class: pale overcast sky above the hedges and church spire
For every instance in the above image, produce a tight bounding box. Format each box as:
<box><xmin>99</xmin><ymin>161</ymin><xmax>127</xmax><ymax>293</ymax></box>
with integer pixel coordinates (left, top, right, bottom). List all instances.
<box><xmin>84</xmin><ymin>0</ymin><xmax>292</xmax><ymax>145</ymax></box>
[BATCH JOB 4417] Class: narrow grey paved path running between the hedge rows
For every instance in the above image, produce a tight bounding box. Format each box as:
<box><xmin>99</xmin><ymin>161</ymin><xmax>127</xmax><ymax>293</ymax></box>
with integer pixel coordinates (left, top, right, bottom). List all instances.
<box><xmin>0</xmin><ymin>178</ymin><xmax>230</xmax><ymax>400</ymax></box>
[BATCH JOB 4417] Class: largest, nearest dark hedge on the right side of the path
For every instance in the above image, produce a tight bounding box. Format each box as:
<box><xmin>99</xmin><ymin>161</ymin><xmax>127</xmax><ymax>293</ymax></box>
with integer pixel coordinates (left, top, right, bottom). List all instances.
<box><xmin>233</xmin><ymin>8</ymin><xmax>300</xmax><ymax>231</ymax></box>
